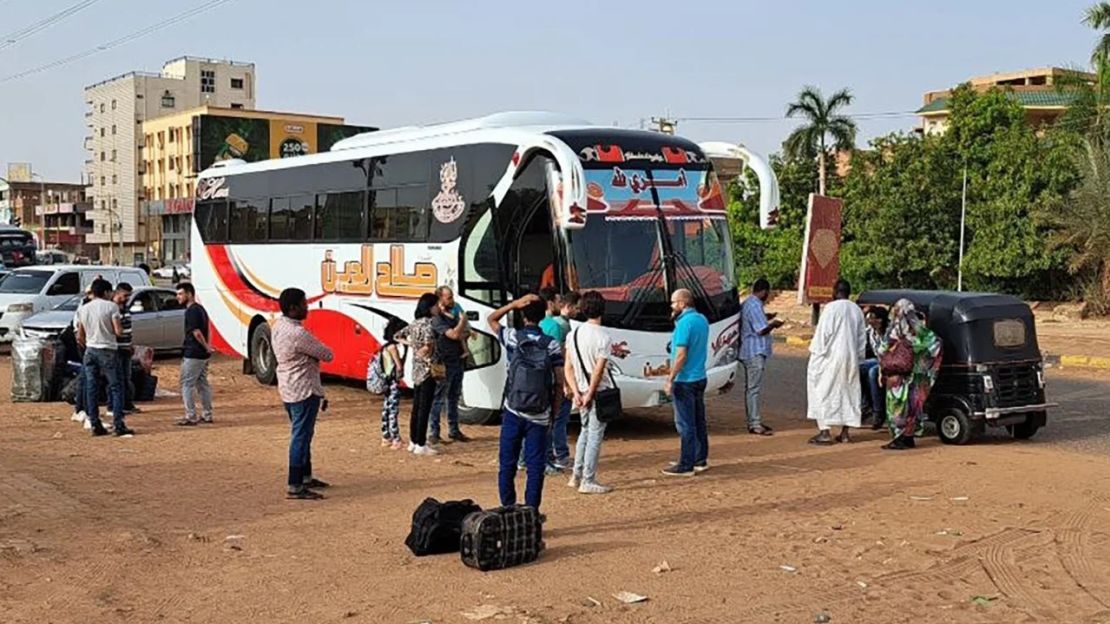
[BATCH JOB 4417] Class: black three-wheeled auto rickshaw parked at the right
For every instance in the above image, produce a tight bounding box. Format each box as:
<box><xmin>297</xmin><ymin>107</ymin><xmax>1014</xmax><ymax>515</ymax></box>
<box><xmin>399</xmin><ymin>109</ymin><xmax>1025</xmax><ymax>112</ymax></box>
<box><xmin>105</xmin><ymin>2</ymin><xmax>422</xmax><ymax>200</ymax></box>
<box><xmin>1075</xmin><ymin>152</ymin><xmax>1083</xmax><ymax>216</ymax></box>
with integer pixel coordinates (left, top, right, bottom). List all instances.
<box><xmin>857</xmin><ymin>290</ymin><xmax>1055</xmax><ymax>444</ymax></box>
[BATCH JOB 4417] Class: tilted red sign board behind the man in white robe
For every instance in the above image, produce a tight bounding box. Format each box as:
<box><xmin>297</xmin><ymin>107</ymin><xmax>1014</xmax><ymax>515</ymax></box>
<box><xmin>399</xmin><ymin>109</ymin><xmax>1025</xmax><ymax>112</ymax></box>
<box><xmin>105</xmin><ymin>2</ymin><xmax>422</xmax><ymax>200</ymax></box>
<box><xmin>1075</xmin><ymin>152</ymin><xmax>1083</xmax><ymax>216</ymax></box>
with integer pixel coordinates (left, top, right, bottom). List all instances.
<box><xmin>798</xmin><ymin>193</ymin><xmax>844</xmax><ymax>303</ymax></box>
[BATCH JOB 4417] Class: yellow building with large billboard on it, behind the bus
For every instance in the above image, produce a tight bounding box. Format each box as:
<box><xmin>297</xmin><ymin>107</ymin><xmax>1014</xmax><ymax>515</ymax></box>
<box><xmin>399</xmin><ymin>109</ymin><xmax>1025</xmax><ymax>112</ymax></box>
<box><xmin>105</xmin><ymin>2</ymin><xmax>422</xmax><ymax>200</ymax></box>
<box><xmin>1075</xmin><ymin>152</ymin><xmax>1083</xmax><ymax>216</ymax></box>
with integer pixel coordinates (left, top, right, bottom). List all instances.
<box><xmin>139</xmin><ymin>105</ymin><xmax>374</xmax><ymax>263</ymax></box>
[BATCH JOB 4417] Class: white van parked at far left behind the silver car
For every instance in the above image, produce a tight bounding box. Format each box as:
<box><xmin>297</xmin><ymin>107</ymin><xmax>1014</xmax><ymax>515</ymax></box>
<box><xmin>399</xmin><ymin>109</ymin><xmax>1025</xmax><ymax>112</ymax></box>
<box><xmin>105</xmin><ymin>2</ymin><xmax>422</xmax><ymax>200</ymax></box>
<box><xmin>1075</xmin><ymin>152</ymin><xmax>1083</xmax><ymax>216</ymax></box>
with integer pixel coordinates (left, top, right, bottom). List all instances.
<box><xmin>0</xmin><ymin>264</ymin><xmax>151</xmax><ymax>343</ymax></box>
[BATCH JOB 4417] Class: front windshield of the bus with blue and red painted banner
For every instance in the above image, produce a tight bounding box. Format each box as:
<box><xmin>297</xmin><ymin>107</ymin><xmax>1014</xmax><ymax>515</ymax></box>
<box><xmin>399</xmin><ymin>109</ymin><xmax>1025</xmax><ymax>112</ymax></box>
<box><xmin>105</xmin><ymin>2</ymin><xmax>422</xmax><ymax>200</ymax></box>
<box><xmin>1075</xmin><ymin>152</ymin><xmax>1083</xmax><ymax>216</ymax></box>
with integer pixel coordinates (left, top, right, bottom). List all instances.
<box><xmin>567</xmin><ymin>168</ymin><xmax>736</xmax><ymax>320</ymax></box>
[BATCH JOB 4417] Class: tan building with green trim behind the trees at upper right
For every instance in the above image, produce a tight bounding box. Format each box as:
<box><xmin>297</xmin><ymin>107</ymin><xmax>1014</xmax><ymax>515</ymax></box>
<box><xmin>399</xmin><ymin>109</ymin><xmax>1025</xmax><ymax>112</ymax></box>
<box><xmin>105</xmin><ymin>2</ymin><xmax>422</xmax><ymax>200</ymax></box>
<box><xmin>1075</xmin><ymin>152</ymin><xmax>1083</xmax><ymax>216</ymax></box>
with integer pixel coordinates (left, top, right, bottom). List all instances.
<box><xmin>917</xmin><ymin>68</ymin><xmax>1096</xmax><ymax>134</ymax></box>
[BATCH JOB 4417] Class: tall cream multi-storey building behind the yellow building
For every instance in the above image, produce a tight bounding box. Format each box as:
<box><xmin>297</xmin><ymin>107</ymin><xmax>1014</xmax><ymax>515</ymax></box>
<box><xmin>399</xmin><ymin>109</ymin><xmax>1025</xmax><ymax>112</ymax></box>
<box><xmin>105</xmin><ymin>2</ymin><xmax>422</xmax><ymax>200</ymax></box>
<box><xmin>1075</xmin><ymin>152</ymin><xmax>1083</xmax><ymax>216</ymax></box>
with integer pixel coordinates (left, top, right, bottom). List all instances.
<box><xmin>84</xmin><ymin>57</ymin><xmax>256</xmax><ymax>264</ymax></box>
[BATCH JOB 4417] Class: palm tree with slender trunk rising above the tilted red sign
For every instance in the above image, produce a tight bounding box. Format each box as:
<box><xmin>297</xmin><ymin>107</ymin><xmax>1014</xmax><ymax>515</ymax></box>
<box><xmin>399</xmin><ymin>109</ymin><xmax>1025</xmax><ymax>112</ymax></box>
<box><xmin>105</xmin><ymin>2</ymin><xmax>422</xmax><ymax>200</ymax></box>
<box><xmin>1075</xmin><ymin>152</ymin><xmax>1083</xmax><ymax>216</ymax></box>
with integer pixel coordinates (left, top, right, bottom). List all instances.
<box><xmin>784</xmin><ymin>85</ymin><xmax>856</xmax><ymax>195</ymax></box>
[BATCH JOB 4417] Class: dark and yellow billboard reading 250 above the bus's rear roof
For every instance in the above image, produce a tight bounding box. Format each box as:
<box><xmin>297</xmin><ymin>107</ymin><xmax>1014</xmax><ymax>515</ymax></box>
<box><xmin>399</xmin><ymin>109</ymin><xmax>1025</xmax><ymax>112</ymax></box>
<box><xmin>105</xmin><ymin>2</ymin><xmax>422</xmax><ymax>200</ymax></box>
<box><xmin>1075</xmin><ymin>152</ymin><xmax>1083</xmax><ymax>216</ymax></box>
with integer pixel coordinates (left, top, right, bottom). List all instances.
<box><xmin>193</xmin><ymin>114</ymin><xmax>377</xmax><ymax>173</ymax></box>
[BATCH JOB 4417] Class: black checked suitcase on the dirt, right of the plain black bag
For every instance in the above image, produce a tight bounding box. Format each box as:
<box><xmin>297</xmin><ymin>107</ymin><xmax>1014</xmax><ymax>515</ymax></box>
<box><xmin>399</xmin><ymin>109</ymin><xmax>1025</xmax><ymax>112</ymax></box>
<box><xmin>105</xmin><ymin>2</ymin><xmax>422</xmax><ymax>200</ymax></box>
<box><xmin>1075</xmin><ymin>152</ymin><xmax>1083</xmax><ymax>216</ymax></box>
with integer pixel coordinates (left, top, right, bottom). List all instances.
<box><xmin>460</xmin><ymin>505</ymin><xmax>544</xmax><ymax>571</ymax></box>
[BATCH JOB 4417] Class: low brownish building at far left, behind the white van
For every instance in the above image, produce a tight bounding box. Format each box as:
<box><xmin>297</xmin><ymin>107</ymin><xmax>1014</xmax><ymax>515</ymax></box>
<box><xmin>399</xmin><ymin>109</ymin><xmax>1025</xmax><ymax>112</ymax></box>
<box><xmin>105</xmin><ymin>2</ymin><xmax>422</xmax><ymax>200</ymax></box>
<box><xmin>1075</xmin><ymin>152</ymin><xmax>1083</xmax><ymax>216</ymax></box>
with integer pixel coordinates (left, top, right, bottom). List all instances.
<box><xmin>0</xmin><ymin>181</ymin><xmax>98</xmax><ymax>259</ymax></box>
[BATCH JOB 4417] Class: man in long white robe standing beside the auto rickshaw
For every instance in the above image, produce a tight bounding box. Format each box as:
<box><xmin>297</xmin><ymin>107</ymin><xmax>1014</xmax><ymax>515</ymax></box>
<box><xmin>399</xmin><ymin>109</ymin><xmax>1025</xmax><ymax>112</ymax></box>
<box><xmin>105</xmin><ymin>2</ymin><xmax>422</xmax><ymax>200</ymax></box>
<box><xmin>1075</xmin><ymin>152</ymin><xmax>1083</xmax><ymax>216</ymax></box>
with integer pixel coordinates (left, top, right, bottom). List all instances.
<box><xmin>806</xmin><ymin>280</ymin><xmax>867</xmax><ymax>444</ymax></box>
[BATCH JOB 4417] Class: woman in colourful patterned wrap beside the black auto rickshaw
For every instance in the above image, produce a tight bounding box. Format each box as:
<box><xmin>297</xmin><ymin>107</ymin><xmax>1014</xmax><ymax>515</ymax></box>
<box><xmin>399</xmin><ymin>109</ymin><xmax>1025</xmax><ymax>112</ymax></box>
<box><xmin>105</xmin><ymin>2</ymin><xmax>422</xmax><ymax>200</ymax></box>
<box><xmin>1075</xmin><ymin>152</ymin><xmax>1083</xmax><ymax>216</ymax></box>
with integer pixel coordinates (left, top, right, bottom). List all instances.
<box><xmin>879</xmin><ymin>299</ymin><xmax>941</xmax><ymax>451</ymax></box>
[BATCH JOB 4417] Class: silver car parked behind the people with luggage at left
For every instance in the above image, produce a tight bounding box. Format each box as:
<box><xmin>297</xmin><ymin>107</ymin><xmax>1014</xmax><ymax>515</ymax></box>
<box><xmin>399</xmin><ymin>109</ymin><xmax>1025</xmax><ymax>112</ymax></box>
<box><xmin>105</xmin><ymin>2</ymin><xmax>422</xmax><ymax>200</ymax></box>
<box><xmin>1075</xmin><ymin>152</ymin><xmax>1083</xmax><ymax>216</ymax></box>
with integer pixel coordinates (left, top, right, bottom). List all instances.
<box><xmin>21</xmin><ymin>286</ymin><xmax>185</xmax><ymax>352</ymax></box>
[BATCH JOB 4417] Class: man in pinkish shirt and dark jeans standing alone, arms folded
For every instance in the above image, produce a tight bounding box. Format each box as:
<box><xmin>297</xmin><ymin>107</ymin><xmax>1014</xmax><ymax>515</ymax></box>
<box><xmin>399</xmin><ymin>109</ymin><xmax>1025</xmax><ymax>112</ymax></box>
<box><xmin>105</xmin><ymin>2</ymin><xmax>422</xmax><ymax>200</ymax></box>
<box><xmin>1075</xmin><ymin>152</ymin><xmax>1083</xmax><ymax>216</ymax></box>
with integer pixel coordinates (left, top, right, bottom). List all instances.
<box><xmin>272</xmin><ymin>289</ymin><xmax>333</xmax><ymax>501</ymax></box>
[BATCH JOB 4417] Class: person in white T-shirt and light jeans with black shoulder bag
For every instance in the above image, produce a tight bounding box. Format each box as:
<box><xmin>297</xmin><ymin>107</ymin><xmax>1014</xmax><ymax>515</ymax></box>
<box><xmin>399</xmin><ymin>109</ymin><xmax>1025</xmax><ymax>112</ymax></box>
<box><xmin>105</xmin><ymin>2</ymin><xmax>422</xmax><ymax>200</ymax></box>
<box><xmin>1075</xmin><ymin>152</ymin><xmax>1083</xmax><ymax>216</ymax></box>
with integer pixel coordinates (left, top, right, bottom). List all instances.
<box><xmin>564</xmin><ymin>291</ymin><xmax>613</xmax><ymax>494</ymax></box>
